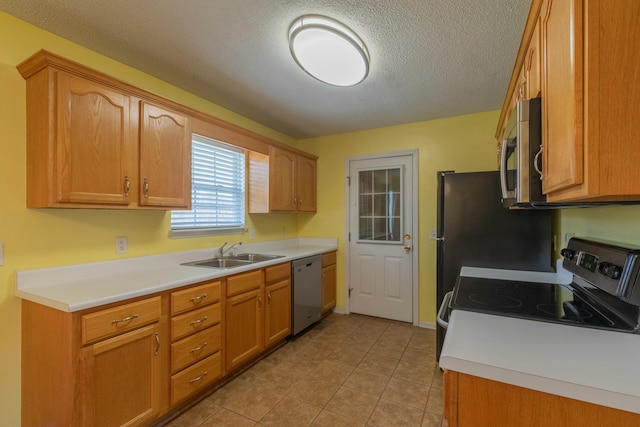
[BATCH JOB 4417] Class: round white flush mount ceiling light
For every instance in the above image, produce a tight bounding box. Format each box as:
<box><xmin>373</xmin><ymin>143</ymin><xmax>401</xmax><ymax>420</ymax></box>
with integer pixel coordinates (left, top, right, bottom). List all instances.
<box><xmin>289</xmin><ymin>15</ymin><xmax>369</xmax><ymax>86</ymax></box>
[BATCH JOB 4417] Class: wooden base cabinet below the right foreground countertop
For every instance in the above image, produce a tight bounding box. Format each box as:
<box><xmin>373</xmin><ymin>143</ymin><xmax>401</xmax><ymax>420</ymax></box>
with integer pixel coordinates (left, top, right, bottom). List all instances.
<box><xmin>443</xmin><ymin>371</ymin><xmax>640</xmax><ymax>427</ymax></box>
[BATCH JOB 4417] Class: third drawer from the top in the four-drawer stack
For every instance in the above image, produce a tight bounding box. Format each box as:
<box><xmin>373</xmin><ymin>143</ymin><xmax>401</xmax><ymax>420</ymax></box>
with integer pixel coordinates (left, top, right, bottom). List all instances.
<box><xmin>171</xmin><ymin>325</ymin><xmax>220</xmax><ymax>372</ymax></box>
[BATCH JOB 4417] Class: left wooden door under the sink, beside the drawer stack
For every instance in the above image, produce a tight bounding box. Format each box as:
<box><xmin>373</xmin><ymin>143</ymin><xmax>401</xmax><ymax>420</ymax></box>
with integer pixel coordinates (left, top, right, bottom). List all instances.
<box><xmin>225</xmin><ymin>287</ymin><xmax>264</xmax><ymax>372</ymax></box>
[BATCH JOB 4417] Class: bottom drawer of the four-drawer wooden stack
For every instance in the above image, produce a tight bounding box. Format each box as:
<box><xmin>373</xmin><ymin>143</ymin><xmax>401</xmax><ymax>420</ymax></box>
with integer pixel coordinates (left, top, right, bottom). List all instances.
<box><xmin>171</xmin><ymin>352</ymin><xmax>222</xmax><ymax>405</ymax></box>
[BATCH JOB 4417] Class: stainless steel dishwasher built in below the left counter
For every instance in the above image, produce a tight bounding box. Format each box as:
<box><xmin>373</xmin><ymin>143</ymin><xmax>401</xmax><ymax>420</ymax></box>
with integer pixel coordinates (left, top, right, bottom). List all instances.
<box><xmin>291</xmin><ymin>255</ymin><xmax>322</xmax><ymax>335</ymax></box>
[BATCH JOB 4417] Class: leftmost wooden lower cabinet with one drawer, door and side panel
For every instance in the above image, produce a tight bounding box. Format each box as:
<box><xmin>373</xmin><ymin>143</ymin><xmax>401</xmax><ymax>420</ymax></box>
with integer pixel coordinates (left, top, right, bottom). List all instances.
<box><xmin>22</xmin><ymin>297</ymin><xmax>168</xmax><ymax>427</ymax></box>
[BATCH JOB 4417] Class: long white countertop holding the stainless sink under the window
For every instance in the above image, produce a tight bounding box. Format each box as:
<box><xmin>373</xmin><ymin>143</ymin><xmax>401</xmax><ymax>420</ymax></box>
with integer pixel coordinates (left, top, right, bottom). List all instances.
<box><xmin>15</xmin><ymin>238</ymin><xmax>338</xmax><ymax>312</ymax></box>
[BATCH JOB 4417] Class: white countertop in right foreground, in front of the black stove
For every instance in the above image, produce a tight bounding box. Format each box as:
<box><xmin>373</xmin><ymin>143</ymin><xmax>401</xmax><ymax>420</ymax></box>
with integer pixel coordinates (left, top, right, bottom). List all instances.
<box><xmin>440</xmin><ymin>260</ymin><xmax>640</xmax><ymax>413</ymax></box>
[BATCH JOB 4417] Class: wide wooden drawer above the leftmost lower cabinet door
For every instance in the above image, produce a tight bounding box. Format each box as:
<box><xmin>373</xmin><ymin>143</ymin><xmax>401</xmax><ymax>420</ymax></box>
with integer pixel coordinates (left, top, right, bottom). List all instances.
<box><xmin>81</xmin><ymin>296</ymin><xmax>161</xmax><ymax>344</ymax></box>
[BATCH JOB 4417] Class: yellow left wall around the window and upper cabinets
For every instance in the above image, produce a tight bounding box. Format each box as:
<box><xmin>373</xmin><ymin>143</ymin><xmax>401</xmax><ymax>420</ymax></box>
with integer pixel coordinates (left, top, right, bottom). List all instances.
<box><xmin>0</xmin><ymin>12</ymin><xmax>297</xmax><ymax>426</ymax></box>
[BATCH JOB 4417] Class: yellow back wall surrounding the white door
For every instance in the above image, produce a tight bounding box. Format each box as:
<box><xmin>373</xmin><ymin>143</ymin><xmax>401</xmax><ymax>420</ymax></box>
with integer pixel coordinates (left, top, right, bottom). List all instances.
<box><xmin>298</xmin><ymin>111</ymin><xmax>499</xmax><ymax>323</ymax></box>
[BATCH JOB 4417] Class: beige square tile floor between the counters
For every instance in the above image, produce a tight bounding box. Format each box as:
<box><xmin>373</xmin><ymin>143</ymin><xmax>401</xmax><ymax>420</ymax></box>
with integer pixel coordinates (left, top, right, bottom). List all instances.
<box><xmin>168</xmin><ymin>314</ymin><xmax>443</xmax><ymax>427</ymax></box>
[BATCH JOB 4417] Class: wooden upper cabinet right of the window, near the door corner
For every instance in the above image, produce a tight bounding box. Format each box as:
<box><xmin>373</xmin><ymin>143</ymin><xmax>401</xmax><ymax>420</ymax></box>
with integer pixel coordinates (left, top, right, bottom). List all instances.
<box><xmin>249</xmin><ymin>145</ymin><xmax>317</xmax><ymax>213</ymax></box>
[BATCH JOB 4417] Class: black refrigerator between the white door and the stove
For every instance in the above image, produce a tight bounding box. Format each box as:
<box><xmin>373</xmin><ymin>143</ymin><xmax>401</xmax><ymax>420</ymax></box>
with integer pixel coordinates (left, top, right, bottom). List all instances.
<box><xmin>436</xmin><ymin>171</ymin><xmax>553</xmax><ymax>360</ymax></box>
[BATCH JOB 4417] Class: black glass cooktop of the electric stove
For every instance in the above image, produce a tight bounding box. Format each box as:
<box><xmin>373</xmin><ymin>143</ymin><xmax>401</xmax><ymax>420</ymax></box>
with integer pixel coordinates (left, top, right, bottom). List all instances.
<box><xmin>451</xmin><ymin>277</ymin><xmax>630</xmax><ymax>329</ymax></box>
